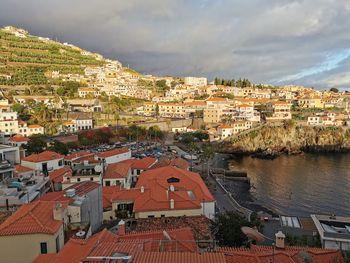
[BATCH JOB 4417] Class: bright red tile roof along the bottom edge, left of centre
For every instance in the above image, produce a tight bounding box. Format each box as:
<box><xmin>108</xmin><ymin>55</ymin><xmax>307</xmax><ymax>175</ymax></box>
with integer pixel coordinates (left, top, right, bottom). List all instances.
<box><xmin>34</xmin><ymin>228</ymin><xmax>205</xmax><ymax>263</ymax></box>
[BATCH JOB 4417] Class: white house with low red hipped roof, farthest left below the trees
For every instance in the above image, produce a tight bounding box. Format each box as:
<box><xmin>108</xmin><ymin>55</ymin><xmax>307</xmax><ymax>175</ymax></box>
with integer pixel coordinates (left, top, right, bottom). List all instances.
<box><xmin>21</xmin><ymin>151</ymin><xmax>64</xmax><ymax>175</ymax></box>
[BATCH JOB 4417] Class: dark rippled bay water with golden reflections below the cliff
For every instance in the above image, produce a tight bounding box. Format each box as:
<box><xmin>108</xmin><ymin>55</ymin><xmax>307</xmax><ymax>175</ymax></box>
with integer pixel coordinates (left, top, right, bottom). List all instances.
<box><xmin>229</xmin><ymin>154</ymin><xmax>350</xmax><ymax>216</ymax></box>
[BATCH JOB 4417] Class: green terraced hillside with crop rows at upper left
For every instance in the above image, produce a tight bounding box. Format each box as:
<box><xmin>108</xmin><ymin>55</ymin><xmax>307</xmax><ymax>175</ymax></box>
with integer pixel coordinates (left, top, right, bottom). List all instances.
<box><xmin>0</xmin><ymin>27</ymin><xmax>105</xmax><ymax>85</ymax></box>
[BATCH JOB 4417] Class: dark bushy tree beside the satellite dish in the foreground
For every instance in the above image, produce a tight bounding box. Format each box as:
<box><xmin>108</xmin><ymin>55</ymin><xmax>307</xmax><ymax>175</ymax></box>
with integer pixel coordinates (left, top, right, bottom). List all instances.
<box><xmin>212</xmin><ymin>211</ymin><xmax>254</xmax><ymax>247</ymax></box>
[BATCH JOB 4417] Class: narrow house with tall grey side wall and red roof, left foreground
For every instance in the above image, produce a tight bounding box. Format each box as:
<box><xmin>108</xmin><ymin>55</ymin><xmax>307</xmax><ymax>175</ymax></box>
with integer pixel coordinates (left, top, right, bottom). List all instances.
<box><xmin>40</xmin><ymin>181</ymin><xmax>103</xmax><ymax>233</ymax></box>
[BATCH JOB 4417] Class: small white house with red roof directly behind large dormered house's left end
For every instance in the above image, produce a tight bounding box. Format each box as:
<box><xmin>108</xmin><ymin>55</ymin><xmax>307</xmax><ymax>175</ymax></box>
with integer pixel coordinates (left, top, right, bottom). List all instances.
<box><xmin>103</xmin><ymin>162</ymin><xmax>132</xmax><ymax>189</ymax></box>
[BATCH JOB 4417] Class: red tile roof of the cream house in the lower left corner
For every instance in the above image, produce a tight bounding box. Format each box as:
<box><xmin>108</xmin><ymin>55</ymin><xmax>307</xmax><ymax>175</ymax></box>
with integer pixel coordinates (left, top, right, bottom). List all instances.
<box><xmin>0</xmin><ymin>201</ymin><xmax>62</xmax><ymax>236</ymax></box>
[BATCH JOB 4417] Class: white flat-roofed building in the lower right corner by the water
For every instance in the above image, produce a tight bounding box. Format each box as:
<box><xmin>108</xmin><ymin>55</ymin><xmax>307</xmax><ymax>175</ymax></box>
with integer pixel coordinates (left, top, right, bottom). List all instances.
<box><xmin>311</xmin><ymin>215</ymin><xmax>350</xmax><ymax>251</ymax></box>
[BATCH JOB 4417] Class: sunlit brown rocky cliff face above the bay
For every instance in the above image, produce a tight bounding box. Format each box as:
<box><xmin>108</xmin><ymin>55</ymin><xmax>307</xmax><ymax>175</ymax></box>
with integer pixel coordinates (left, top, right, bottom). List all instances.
<box><xmin>222</xmin><ymin>123</ymin><xmax>350</xmax><ymax>155</ymax></box>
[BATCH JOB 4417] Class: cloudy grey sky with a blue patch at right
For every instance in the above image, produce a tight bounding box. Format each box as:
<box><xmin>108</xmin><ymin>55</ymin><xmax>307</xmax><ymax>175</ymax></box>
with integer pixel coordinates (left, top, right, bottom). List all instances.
<box><xmin>0</xmin><ymin>0</ymin><xmax>350</xmax><ymax>89</ymax></box>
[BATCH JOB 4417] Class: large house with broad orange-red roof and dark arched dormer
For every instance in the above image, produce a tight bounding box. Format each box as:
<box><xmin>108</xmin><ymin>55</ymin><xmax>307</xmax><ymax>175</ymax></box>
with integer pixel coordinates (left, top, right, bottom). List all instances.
<box><xmin>104</xmin><ymin>166</ymin><xmax>215</xmax><ymax>221</ymax></box>
